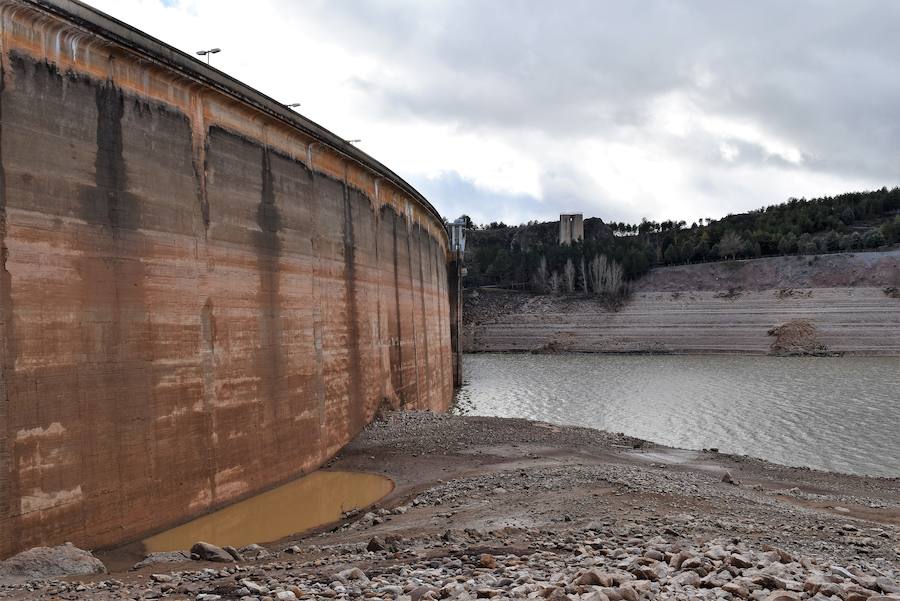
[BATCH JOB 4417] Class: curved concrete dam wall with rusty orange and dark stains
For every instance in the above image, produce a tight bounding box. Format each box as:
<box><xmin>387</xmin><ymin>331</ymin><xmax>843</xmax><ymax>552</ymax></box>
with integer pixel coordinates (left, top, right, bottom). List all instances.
<box><xmin>0</xmin><ymin>0</ymin><xmax>453</xmax><ymax>557</ymax></box>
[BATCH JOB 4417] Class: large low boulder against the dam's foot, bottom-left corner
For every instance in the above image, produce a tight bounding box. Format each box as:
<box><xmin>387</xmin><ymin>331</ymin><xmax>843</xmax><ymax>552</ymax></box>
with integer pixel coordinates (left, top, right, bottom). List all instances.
<box><xmin>0</xmin><ymin>543</ymin><xmax>106</xmax><ymax>580</ymax></box>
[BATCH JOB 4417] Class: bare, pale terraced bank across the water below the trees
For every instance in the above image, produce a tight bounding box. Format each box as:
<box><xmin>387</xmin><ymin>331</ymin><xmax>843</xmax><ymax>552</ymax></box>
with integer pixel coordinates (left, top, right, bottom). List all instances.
<box><xmin>464</xmin><ymin>251</ymin><xmax>900</xmax><ymax>355</ymax></box>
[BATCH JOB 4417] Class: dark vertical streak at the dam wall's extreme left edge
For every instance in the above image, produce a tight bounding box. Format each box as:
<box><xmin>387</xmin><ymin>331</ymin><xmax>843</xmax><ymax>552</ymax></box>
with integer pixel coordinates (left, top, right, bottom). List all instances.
<box><xmin>0</xmin><ymin>58</ymin><xmax>16</xmax><ymax>557</ymax></box>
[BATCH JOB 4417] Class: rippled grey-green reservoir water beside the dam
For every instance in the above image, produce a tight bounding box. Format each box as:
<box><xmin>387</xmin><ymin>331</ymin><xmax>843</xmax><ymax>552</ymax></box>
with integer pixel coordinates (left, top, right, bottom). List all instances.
<box><xmin>457</xmin><ymin>354</ymin><xmax>900</xmax><ymax>476</ymax></box>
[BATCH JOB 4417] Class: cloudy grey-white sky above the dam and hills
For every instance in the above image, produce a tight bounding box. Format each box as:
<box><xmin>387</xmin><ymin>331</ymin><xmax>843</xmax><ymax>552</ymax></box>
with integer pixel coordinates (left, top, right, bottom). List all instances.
<box><xmin>89</xmin><ymin>0</ymin><xmax>900</xmax><ymax>223</ymax></box>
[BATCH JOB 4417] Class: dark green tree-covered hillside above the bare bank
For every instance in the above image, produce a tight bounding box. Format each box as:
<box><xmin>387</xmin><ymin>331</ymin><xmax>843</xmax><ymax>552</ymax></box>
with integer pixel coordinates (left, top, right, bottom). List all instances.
<box><xmin>465</xmin><ymin>188</ymin><xmax>900</xmax><ymax>296</ymax></box>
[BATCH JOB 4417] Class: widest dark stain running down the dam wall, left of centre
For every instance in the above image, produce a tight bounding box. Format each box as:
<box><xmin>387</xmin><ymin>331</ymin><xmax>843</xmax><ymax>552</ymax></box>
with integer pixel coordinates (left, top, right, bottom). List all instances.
<box><xmin>72</xmin><ymin>76</ymin><xmax>153</xmax><ymax>528</ymax></box>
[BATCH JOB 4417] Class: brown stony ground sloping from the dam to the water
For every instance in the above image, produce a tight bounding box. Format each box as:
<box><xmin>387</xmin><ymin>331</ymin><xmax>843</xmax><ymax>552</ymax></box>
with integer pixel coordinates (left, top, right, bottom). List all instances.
<box><xmin>0</xmin><ymin>413</ymin><xmax>900</xmax><ymax>601</ymax></box>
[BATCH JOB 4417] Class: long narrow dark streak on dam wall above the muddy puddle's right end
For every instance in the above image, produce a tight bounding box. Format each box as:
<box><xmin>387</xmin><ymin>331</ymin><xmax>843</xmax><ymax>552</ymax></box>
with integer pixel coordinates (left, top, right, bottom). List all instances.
<box><xmin>343</xmin><ymin>182</ymin><xmax>367</xmax><ymax>436</ymax></box>
